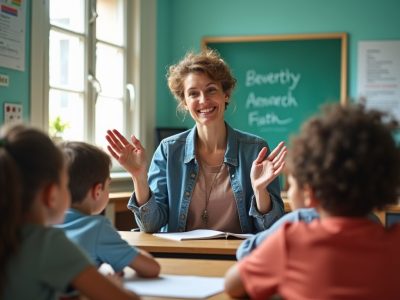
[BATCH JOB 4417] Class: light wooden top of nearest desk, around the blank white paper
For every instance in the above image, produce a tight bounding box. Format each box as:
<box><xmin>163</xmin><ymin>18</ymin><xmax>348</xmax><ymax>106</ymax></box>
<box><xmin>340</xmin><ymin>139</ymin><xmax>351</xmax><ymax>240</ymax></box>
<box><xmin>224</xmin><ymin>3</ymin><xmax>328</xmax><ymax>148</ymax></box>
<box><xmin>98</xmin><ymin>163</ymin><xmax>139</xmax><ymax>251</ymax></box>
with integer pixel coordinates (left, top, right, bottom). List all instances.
<box><xmin>126</xmin><ymin>258</ymin><xmax>235</xmax><ymax>300</ymax></box>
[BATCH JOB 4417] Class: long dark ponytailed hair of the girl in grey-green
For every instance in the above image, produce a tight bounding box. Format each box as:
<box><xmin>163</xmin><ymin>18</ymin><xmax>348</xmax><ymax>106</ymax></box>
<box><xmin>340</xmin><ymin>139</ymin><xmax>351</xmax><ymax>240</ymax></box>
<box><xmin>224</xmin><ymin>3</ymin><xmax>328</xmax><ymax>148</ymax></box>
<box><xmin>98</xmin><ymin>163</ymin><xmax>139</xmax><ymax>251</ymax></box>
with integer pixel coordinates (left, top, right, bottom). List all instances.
<box><xmin>0</xmin><ymin>124</ymin><xmax>64</xmax><ymax>294</ymax></box>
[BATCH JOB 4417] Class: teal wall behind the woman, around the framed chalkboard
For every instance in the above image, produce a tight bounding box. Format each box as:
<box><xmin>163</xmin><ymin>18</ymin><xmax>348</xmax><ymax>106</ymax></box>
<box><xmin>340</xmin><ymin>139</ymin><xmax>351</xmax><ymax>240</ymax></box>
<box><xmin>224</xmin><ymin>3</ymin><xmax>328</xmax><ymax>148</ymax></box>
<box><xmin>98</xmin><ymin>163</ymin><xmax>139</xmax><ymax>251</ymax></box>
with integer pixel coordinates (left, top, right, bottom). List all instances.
<box><xmin>156</xmin><ymin>0</ymin><xmax>400</xmax><ymax>126</ymax></box>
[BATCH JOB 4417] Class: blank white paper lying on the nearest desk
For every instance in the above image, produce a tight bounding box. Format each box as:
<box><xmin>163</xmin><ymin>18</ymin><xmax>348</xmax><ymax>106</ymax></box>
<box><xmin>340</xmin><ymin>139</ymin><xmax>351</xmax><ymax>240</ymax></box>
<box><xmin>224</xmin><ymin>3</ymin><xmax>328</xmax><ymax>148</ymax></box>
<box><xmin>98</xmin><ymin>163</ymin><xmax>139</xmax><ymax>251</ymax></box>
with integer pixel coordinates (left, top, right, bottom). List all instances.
<box><xmin>124</xmin><ymin>274</ymin><xmax>224</xmax><ymax>299</ymax></box>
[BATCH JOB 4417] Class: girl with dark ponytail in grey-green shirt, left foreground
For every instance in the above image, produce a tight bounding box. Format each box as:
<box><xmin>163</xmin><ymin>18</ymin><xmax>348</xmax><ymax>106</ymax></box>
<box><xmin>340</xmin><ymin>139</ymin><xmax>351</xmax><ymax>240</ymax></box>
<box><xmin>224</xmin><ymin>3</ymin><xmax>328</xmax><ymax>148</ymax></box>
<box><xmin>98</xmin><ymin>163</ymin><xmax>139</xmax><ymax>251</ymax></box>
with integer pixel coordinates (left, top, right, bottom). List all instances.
<box><xmin>0</xmin><ymin>124</ymin><xmax>138</xmax><ymax>300</ymax></box>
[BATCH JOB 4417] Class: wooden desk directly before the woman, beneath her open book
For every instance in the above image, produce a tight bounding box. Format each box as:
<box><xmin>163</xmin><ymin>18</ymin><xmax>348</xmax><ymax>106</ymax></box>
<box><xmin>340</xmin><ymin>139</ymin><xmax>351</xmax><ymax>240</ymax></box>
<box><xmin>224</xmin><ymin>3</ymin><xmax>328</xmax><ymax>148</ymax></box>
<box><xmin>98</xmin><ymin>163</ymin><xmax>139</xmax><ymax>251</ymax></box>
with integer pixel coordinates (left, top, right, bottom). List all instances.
<box><xmin>119</xmin><ymin>231</ymin><xmax>243</xmax><ymax>260</ymax></box>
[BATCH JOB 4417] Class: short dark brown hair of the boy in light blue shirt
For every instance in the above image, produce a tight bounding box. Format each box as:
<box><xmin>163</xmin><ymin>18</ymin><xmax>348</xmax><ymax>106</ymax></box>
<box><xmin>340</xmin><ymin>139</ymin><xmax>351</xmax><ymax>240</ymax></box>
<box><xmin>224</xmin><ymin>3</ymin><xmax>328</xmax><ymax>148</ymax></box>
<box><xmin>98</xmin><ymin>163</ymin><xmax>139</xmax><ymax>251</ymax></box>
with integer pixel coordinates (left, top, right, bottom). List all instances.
<box><xmin>60</xmin><ymin>142</ymin><xmax>111</xmax><ymax>203</ymax></box>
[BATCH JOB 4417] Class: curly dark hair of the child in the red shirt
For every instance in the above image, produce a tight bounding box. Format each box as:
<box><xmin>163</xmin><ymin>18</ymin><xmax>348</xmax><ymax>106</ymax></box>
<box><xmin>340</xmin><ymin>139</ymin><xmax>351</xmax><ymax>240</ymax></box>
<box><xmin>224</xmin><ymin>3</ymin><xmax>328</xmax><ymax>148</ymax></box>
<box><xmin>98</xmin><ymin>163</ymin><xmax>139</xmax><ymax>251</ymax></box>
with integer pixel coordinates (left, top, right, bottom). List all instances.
<box><xmin>287</xmin><ymin>104</ymin><xmax>400</xmax><ymax>216</ymax></box>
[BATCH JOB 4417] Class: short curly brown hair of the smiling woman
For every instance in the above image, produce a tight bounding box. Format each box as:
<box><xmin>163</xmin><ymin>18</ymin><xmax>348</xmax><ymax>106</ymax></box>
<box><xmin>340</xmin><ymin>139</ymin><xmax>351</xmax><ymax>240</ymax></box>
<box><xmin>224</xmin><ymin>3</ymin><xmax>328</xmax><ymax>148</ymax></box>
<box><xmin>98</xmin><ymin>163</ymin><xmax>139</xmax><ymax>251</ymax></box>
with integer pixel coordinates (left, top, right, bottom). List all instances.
<box><xmin>167</xmin><ymin>49</ymin><xmax>236</xmax><ymax>109</ymax></box>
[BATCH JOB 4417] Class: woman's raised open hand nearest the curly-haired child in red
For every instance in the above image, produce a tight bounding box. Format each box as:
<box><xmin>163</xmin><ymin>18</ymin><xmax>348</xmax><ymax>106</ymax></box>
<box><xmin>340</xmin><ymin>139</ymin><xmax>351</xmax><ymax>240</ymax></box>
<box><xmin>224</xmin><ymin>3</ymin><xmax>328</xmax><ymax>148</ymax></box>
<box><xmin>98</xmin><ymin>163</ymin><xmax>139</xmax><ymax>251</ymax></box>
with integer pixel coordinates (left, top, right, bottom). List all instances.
<box><xmin>250</xmin><ymin>142</ymin><xmax>287</xmax><ymax>190</ymax></box>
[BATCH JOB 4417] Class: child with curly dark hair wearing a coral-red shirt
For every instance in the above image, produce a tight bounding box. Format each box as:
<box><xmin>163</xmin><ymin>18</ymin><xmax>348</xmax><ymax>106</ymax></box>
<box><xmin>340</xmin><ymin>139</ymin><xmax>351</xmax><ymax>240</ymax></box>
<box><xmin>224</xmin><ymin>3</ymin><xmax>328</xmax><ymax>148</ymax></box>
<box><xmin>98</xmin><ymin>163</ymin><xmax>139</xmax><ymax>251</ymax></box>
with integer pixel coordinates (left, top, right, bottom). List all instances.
<box><xmin>225</xmin><ymin>105</ymin><xmax>400</xmax><ymax>300</ymax></box>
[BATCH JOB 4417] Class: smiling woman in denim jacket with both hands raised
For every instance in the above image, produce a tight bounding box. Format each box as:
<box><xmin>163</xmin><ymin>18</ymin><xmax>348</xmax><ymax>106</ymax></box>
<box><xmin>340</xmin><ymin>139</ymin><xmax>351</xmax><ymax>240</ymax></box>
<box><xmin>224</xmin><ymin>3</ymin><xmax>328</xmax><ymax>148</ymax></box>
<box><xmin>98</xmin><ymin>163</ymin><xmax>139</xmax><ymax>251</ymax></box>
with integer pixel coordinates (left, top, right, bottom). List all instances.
<box><xmin>106</xmin><ymin>50</ymin><xmax>287</xmax><ymax>233</ymax></box>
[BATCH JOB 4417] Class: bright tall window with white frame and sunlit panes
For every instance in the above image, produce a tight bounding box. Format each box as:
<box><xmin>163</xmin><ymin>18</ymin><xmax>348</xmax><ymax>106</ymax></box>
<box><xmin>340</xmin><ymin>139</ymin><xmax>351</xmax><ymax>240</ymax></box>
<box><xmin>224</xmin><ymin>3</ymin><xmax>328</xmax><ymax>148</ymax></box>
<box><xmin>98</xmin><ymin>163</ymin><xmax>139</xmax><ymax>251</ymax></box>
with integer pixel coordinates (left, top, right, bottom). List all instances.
<box><xmin>48</xmin><ymin>0</ymin><xmax>127</xmax><ymax>145</ymax></box>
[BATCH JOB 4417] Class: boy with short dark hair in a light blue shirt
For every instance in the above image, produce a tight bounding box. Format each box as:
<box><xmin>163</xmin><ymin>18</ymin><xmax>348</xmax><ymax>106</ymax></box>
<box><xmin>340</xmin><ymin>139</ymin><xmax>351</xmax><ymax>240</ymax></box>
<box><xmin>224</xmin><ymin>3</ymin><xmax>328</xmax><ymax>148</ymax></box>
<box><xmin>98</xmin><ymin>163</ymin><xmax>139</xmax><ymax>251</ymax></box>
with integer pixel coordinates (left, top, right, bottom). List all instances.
<box><xmin>58</xmin><ymin>142</ymin><xmax>160</xmax><ymax>277</ymax></box>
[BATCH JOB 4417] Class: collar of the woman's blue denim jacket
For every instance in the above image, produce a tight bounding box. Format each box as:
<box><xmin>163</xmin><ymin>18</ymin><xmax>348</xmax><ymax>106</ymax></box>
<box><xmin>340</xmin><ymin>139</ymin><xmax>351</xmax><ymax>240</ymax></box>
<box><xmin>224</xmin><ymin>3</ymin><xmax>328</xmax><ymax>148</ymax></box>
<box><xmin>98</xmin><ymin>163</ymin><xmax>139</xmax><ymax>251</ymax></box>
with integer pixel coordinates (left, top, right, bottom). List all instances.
<box><xmin>184</xmin><ymin>122</ymin><xmax>238</xmax><ymax>167</ymax></box>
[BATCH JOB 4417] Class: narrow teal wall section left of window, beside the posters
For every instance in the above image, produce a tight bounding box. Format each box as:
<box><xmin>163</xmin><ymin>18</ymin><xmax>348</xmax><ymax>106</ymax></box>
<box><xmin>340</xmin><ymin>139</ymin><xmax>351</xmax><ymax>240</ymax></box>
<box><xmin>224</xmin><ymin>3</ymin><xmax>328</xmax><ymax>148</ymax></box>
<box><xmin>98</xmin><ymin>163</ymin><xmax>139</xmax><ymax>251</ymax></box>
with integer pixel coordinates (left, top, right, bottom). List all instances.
<box><xmin>0</xmin><ymin>0</ymin><xmax>31</xmax><ymax>124</ymax></box>
